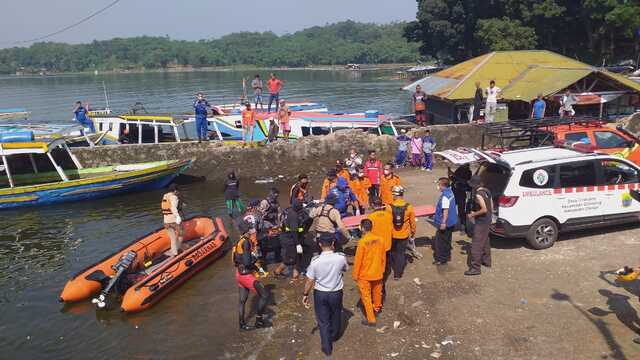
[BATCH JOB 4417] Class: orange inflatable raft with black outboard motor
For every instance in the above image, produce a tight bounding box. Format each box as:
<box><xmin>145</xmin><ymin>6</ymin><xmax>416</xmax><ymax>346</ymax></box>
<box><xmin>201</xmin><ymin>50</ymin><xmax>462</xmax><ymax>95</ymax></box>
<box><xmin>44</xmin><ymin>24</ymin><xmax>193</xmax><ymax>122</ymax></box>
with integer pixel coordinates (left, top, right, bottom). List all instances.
<box><xmin>60</xmin><ymin>217</ymin><xmax>228</xmax><ymax>312</ymax></box>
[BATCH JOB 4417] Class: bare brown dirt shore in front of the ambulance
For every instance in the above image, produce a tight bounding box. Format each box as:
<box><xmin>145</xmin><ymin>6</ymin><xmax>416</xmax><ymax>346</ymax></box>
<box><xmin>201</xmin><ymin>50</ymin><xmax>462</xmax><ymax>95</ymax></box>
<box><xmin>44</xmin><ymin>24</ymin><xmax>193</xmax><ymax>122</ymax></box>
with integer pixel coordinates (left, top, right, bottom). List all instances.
<box><xmin>228</xmin><ymin>170</ymin><xmax>640</xmax><ymax>359</ymax></box>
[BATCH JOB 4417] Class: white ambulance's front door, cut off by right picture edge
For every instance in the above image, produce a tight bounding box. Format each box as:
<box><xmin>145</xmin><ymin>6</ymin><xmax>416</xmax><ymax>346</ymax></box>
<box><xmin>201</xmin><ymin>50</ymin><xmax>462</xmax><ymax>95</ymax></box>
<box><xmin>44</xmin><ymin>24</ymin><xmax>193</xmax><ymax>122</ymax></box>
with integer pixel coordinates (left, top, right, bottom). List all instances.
<box><xmin>598</xmin><ymin>159</ymin><xmax>640</xmax><ymax>222</ymax></box>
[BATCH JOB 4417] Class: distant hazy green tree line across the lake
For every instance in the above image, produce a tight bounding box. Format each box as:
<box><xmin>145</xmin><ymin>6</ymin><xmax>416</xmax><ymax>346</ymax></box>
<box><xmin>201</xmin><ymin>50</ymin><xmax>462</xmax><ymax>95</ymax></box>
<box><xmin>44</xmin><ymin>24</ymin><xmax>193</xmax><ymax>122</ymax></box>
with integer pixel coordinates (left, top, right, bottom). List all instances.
<box><xmin>0</xmin><ymin>21</ymin><xmax>420</xmax><ymax>73</ymax></box>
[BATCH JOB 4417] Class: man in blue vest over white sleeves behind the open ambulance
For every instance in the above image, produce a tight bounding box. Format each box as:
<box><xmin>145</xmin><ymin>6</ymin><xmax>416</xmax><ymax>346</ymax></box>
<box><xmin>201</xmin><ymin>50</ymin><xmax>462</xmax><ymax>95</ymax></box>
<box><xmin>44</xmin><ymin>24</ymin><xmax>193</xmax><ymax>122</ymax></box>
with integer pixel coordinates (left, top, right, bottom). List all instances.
<box><xmin>433</xmin><ymin>177</ymin><xmax>458</xmax><ymax>265</ymax></box>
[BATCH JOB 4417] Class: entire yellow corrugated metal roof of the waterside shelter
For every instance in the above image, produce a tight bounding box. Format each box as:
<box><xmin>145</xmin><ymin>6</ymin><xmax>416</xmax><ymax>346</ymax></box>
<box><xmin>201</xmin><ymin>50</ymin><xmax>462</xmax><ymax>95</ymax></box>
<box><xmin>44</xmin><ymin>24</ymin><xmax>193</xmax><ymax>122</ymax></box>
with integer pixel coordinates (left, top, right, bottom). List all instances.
<box><xmin>405</xmin><ymin>50</ymin><xmax>640</xmax><ymax>101</ymax></box>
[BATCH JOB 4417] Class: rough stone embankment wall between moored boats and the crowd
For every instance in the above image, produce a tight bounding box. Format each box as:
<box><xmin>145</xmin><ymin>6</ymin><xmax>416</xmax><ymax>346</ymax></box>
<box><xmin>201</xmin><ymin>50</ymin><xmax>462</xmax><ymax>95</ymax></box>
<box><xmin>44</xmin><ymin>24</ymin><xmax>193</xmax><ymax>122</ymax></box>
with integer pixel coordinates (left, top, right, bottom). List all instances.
<box><xmin>73</xmin><ymin>125</ymin><xmax>481</xmax><ymax>180</ymax></box>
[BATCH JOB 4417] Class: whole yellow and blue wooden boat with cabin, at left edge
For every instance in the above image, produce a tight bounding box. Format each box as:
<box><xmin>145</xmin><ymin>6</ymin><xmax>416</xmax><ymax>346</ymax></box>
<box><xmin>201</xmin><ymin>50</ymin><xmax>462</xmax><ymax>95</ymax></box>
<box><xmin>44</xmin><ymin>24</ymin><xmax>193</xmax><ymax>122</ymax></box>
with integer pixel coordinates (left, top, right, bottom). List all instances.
<box><xmin>0</xmin><ymin>134</ymin><xmax>193</xmax><ymax>209</ymax></box>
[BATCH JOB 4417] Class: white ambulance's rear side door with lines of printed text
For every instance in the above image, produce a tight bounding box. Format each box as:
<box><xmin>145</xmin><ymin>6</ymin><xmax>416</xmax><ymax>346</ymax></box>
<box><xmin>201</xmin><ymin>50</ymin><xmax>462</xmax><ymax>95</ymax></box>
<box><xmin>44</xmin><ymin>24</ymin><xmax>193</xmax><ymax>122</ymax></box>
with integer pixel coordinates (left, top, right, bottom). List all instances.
<box><xmin>553</xmin><ymin>160</ymin><xmax>605</xmax><ymax>228</ymax></box>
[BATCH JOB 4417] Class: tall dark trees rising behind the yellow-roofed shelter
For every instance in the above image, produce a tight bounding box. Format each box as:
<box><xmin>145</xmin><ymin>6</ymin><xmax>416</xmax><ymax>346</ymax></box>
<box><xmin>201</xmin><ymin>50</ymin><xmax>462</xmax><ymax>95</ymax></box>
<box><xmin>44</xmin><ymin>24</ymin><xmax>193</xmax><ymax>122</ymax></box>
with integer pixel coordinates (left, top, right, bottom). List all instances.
<box><xmin>405</xmin><ymin>0</ymin><xmax>640</xmax><ymax>65</ymax></box>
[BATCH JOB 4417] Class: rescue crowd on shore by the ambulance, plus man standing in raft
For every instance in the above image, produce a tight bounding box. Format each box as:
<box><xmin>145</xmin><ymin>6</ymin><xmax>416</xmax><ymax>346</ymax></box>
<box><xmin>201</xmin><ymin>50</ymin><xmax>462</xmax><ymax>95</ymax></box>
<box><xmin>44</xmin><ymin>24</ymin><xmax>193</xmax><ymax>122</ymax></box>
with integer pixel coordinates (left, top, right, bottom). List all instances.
<box><xmin>156</xmin><ymin>142</ymin><xmax>504</xmax><ymax>355</ymax></box>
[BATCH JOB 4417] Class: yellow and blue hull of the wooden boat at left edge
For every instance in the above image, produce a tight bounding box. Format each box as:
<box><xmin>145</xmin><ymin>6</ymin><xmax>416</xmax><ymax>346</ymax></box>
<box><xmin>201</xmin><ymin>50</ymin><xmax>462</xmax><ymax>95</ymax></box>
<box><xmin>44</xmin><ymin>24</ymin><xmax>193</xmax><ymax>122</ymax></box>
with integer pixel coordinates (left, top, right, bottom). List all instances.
<box><xmin>0</xmin><ymin>160</ymin><xmax>192</xmax><ymax>209</ymax></box>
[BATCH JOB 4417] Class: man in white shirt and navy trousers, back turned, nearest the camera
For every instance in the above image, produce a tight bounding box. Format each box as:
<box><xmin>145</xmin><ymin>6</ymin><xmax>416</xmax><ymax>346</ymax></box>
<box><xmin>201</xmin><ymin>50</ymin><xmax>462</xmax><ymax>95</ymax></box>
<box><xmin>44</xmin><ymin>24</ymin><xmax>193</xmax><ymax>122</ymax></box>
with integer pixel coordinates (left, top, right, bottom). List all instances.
<box><xmin>302</xmin><ymin>233</ymin><xmax>349</xmax><ymax>356</ymax></box>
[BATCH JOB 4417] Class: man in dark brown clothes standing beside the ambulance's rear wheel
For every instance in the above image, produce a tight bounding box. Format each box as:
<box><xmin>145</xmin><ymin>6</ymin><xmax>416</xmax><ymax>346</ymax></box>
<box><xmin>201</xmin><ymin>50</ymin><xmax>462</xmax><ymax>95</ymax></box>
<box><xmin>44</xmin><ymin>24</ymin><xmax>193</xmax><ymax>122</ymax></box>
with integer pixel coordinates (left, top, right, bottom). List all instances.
<box><xmin>464</xmin><ymin>175</ymin><xmax>493</xmax><ymax>275</ymax></box>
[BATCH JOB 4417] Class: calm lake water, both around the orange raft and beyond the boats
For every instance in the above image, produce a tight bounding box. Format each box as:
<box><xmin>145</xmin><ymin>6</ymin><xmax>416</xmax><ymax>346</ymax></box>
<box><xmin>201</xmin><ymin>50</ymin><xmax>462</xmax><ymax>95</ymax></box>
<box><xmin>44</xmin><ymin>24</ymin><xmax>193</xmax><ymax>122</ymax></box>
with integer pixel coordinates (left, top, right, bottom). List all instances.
<box><xmin>0</xmin><ymin>71</ymin><xmax>407</xmax><ymax>359</ymax></box>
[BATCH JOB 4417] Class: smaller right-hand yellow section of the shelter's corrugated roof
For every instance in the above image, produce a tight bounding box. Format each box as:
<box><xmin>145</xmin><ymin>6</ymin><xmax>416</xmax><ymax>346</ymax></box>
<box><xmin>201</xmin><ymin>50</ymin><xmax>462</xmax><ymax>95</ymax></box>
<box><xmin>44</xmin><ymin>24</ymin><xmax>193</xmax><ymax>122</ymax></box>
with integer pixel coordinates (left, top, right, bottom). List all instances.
<box><xmin>502</xmin><ymin>67</ymin><xmax>591</xmax><ymax>101</ymax></box>
